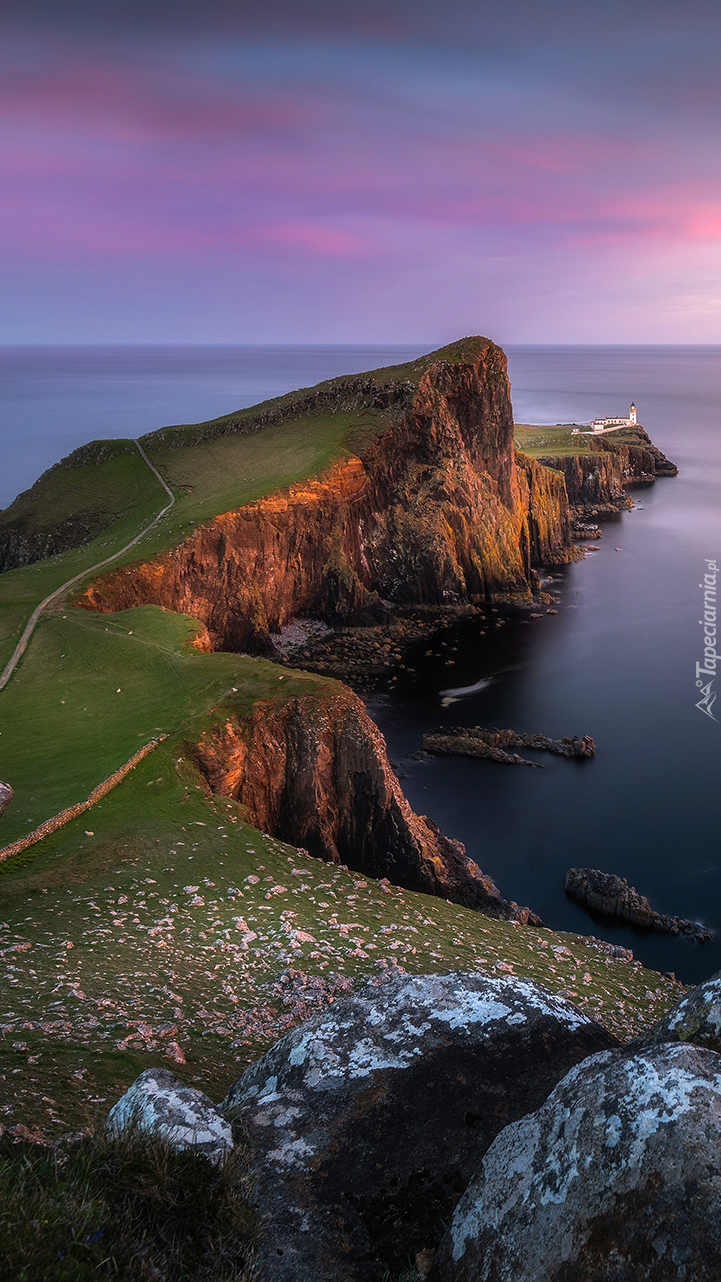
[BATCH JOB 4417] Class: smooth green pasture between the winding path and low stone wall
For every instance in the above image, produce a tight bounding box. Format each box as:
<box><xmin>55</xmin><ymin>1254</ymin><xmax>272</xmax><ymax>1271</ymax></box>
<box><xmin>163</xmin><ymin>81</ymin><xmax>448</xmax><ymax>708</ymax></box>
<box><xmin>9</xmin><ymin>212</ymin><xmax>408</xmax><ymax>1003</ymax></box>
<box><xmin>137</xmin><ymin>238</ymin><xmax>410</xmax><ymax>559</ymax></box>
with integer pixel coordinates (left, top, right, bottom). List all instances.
<box><xmin>0</xmin><ymin>605</ymin><xmax>316</xmax><ymax>845</ymax></box>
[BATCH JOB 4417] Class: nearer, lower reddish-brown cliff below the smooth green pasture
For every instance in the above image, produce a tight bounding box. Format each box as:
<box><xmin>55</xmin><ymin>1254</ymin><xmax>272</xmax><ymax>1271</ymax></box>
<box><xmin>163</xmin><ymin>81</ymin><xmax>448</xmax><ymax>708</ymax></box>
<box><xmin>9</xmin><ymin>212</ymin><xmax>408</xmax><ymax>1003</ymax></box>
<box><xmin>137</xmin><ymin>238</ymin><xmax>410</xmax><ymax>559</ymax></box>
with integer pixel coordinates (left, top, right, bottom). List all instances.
<box><xmin>191</xmin><ymin>683</ymin><xmax>539</xmax><ymax>923</ymax></box>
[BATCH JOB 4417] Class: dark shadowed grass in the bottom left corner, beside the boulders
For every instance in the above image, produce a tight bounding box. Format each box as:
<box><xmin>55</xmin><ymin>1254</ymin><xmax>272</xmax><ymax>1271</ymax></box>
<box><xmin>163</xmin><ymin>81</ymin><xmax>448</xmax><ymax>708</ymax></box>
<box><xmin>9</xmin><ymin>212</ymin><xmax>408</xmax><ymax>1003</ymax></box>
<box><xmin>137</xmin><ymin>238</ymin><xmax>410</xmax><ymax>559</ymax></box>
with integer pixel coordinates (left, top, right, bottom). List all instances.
<box><xmin>0</xmin><ymin>1132</ymin><xmax>255</xmax><ymax>1282</ymax></box>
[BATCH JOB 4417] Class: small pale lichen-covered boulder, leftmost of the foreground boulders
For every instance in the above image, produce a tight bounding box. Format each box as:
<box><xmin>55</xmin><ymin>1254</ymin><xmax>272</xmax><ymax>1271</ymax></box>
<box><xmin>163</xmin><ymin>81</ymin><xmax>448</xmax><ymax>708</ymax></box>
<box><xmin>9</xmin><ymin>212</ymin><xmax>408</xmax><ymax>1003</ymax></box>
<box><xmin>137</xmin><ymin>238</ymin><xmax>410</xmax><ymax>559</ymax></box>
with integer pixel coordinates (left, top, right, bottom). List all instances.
<box><xmin>106</xmin><ymin>1068</ymin><xmax>232</xmax><ymax>1161</ymax></box>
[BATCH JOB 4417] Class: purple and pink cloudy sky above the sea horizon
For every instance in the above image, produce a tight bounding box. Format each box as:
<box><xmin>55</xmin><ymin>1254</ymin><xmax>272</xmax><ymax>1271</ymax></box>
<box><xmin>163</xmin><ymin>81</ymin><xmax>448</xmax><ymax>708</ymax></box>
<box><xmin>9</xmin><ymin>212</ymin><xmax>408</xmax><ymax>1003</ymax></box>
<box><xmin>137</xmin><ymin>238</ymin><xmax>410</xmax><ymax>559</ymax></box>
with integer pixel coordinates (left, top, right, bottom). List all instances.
<box><xmin>0</xmin><ymin>0</ymin><xmax>721</xmax><ymax>345</ymax></box>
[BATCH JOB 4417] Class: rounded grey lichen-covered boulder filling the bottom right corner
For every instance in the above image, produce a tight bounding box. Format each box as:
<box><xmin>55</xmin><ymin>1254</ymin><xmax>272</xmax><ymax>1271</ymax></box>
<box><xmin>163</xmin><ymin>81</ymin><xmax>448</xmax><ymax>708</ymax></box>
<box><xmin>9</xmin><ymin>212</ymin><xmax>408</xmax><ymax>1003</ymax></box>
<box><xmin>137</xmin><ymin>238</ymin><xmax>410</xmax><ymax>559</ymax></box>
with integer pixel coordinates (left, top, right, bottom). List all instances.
<box><xmin>431</xmin><ymin>1046</ymin><xmax>721</xmax><ymax>1282</ymax></box>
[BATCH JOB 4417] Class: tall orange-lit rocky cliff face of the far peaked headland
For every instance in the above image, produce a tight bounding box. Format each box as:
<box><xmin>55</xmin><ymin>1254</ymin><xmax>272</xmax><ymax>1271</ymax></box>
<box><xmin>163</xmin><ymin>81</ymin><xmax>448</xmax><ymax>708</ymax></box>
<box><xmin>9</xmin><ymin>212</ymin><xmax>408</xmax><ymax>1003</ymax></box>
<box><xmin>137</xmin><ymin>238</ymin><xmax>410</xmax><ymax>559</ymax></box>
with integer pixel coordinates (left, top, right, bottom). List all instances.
<box><xmin>80</xmin><ymin>338</ymin><xmax>570</xmax><ymax>651</ymax></box>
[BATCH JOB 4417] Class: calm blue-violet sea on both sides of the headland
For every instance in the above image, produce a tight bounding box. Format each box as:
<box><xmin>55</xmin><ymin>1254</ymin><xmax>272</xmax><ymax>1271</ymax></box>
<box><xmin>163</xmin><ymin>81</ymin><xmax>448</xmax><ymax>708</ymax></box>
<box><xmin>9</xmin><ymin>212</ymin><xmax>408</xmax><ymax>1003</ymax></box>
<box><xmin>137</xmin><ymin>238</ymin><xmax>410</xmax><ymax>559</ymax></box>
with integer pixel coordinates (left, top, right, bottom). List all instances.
<box><xmin>0</xmin><ymin>345</ymin><xmax>721</xmax><ymax>983</ymax></box>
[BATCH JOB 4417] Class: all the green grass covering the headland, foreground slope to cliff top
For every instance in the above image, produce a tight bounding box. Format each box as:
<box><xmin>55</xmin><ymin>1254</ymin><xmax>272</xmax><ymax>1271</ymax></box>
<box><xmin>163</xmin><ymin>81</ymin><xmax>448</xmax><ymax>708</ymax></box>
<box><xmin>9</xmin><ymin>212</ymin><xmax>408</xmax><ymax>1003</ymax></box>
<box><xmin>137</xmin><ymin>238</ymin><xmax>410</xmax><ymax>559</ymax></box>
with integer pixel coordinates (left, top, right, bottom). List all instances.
<box><xmin>0</xmin><ymin>342</ymin><xmax>681</xmax><ymax>1133</ymax></box>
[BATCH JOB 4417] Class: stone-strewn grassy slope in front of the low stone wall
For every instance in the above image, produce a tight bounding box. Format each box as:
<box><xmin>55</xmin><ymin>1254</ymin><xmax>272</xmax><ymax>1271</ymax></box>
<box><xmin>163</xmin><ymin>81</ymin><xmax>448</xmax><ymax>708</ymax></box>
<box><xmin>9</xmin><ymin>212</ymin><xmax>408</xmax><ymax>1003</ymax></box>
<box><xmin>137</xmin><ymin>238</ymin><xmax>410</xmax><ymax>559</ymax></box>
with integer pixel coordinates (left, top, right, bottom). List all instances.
<box><xmin>0</xmin><ymin>723</ymin><xmax>684</xmax><ymax>1133</ymax></box>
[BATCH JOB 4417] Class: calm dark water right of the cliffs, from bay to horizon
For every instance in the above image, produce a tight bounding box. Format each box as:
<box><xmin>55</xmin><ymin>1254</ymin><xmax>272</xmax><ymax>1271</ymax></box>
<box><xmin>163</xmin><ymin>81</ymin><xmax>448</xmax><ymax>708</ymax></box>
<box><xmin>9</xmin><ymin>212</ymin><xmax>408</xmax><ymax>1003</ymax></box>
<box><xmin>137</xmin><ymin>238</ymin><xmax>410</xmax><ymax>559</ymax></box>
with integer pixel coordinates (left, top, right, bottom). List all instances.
<box><xmin>371</xmin><ymin>347</ymin><xmax>721</xmax><ymax>982</ymax></box>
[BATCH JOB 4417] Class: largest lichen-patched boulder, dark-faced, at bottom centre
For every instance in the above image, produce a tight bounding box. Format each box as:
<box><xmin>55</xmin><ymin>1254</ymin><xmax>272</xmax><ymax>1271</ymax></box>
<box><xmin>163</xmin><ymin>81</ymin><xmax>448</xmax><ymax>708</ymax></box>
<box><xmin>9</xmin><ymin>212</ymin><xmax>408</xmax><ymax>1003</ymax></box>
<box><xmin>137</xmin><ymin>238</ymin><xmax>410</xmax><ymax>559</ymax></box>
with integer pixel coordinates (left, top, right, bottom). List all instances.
<box><xmin>223</xmin><ymin>974</ymin><xmax>617</xmax><ymax>1282</ymax></box>
